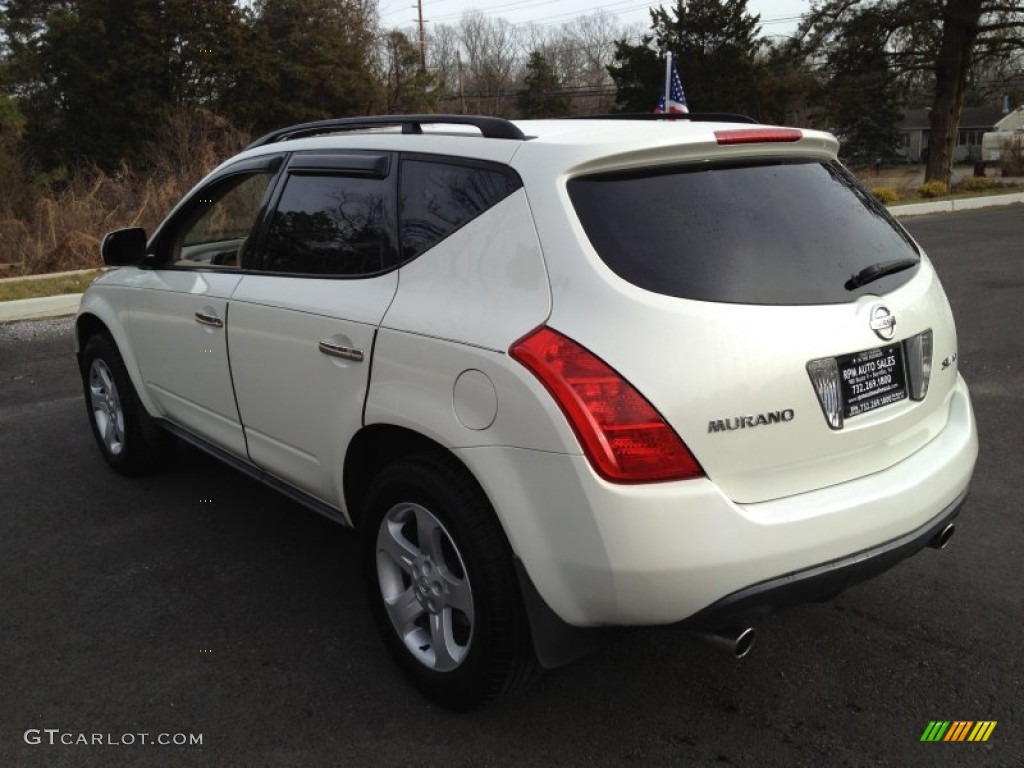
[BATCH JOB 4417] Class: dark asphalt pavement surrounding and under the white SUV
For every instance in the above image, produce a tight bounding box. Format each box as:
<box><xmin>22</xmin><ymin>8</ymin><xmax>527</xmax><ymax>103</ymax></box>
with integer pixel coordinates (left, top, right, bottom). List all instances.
<box><xmin>0</xmin><ymin>206</ymin><xmax>1024</xmax><ymax>768</ymax></box>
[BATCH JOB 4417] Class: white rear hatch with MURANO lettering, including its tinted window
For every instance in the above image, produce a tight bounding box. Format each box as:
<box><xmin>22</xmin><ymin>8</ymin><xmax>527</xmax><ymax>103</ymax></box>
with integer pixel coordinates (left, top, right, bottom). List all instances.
<box><xmin>551</xmin><ymin>150</ymin><xmax>956</xmax><ymax>503</ymax></box>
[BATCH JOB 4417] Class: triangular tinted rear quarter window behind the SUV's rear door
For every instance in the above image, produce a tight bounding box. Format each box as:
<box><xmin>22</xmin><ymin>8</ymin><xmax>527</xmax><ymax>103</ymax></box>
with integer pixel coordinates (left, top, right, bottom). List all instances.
<box><xmin>400</xmin><ymin>159</ymin><xmax>522</xmax><ymax>261</ymax></box>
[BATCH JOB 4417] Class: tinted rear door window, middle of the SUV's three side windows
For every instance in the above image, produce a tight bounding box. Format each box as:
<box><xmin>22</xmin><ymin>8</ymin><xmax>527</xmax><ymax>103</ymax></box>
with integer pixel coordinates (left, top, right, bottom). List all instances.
<box><xmin>262</xmin><ymin>173</ymin><xmax>395</xmax><ymax>276</ymax></box>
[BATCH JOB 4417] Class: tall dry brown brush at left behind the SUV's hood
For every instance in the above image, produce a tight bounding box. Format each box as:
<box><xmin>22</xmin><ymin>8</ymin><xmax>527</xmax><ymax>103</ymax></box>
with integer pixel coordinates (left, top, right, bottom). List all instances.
<box><xmin>0</xmin><ymin>111</ymin><xmax>247</xmax><ymax>276</ymax></box>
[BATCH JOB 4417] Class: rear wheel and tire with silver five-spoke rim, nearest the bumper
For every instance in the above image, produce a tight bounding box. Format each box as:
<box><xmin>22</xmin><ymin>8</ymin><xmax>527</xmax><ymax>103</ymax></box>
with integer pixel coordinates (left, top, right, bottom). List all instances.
<box><xmin>360</xmin><ymin>454</ymin><xmax>540</xmax><ymax>711</ymax></box>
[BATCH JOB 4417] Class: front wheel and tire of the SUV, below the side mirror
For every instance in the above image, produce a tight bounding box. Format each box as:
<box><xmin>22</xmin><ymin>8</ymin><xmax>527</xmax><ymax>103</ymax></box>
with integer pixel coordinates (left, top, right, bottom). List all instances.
<box><xmin>82</xmin><ymin>334</ymin><xmax>173</xmax><ymax>476</ymax></box>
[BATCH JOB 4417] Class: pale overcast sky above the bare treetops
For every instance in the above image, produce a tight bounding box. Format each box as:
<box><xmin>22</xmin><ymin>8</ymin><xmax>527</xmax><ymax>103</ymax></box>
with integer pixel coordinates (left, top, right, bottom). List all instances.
<box><xmin>380</xmin><ymin>0</ymin><xmax>810</xmax><ymax>41</ymax></box>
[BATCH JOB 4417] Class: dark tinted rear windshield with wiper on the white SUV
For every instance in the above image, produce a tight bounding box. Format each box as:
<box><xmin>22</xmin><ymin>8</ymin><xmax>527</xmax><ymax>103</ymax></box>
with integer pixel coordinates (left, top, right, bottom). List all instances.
<box><xmin>568</xmin><ymin>162</ymin><xmax>920</xmax><ymax>304</ymax></box>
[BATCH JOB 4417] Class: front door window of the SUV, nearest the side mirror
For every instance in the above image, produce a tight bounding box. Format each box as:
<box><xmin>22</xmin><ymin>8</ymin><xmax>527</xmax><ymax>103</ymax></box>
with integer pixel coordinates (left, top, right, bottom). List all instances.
<box><xmin>170</xmin><ymin>173</ymin><xmax>273</xmax><ymax>267</ymax></box>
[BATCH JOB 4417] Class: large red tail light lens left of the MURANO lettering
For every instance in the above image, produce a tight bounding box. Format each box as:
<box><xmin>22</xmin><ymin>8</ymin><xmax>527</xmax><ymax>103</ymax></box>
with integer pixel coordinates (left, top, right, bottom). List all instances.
<box><xmin>509</xmin><ymin>328</ymin><xmax>703</xmax><ymax>482</ymax></box>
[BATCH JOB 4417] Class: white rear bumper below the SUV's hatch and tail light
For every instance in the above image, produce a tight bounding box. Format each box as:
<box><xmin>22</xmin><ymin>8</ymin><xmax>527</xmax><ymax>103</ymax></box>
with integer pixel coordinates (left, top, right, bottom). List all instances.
<box><xmin>457</xmin><ymin>372</ymin><xmax>978</xmax><ymax>628</ymax></box>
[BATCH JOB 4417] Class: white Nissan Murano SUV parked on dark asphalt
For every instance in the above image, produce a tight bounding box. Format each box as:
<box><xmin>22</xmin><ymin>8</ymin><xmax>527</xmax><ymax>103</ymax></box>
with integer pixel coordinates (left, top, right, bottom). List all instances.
<box><xmin>77</xmin><ymin>116</ymin><xmax>978</xmax><ymax>709</ymax></box>
